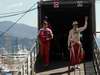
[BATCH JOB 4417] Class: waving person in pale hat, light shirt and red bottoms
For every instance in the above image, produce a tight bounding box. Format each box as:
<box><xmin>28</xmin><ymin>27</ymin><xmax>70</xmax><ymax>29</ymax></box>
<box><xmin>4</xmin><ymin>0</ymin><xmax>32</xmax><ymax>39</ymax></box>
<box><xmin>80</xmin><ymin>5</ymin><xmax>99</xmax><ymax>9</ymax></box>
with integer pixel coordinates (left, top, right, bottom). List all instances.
<box><xmin>68</xmin><ymin>16</ymin><xmax>88</xmax><ymax>68</ymax></box>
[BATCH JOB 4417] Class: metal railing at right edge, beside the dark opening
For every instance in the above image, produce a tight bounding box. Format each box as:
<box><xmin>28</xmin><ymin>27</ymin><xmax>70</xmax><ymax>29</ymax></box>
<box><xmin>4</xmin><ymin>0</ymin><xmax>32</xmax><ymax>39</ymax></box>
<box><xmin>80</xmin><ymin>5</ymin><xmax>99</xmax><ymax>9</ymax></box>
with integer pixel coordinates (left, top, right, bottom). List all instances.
<box><xmin>93</xmin><ymin>35</ymin><xmax>100</xmax><ymax>75</ymax></box>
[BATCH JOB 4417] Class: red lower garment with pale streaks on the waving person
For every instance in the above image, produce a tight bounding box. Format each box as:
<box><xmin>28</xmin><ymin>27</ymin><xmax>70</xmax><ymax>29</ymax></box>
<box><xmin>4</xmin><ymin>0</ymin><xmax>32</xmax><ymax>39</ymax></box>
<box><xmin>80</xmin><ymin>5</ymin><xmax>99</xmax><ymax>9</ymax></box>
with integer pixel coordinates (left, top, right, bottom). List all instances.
<box><xmin>70</xmin><ymin>41</ymin><xmax>85</xmax><ymax>65</ymax></box>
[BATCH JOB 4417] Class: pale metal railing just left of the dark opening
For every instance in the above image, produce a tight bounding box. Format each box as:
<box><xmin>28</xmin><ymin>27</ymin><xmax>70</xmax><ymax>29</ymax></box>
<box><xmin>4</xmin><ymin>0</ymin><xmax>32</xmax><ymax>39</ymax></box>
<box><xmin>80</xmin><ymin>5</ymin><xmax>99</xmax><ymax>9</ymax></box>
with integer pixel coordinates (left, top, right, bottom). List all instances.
<box><xmin>19</xmin><ymin>39</ymin><xmax>39</xmax><ymax>75</ymax></box>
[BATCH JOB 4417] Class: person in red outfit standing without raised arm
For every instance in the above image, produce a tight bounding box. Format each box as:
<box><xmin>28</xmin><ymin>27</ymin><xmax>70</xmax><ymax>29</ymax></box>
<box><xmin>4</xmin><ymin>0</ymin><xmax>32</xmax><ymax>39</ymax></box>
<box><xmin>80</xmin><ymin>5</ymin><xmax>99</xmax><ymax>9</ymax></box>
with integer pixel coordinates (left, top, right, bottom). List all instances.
<box><xmin>39</xmin><ymin>20</ymin><xmax>53</xmax><ymax>65</ymax></box>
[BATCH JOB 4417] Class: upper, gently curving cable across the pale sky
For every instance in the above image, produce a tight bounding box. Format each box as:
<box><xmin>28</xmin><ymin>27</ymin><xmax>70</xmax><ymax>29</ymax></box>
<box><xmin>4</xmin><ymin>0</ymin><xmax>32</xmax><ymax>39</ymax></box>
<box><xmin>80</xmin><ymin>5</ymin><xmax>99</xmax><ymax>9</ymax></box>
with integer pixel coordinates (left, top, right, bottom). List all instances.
<box><xmin>0</xmin><ymin>3</ymin><xmax>37</xmax><ymax>18</ymax></box>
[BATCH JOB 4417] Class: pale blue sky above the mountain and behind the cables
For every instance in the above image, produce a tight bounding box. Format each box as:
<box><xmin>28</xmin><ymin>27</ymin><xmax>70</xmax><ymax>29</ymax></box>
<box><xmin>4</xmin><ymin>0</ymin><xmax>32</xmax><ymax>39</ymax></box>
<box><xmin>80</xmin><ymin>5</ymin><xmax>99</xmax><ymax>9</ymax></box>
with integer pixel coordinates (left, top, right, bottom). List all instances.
<box><xmin>0</xmin><ymin>0</ymin><xmax>100</xmax><ymax>30</ymax></box>
